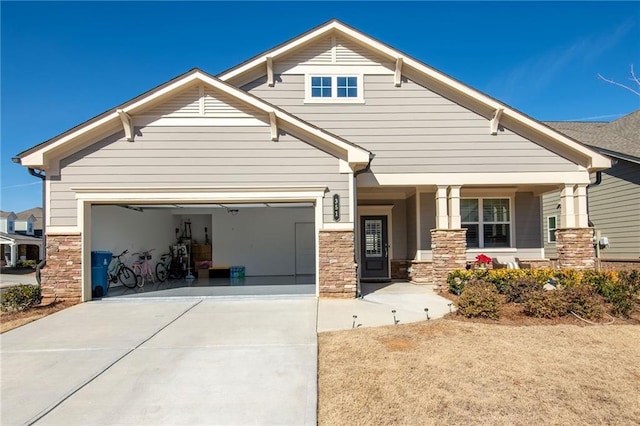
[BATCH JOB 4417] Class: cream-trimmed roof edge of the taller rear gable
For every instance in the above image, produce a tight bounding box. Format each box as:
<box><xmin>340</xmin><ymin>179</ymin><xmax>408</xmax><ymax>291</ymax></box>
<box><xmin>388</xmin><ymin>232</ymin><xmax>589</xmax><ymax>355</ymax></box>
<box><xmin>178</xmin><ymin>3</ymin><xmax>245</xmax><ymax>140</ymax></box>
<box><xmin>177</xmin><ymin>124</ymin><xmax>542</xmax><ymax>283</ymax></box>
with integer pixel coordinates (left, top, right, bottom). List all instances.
<box><xmin>218</xmin><ymin>19</ymin><xmax>611</xmax><ymax>171</ymax></box>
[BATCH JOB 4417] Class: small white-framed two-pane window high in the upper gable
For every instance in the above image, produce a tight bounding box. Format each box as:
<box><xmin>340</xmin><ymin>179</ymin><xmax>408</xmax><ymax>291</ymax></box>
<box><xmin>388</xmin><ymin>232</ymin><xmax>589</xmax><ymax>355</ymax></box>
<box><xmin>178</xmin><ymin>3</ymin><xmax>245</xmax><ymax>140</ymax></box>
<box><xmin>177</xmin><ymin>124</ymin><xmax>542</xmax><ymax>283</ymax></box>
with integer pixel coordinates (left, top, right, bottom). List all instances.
<box><xmin>306</xmin><ymin>75</ymin><xmax>363</xmax><ymax>102</ymax></box>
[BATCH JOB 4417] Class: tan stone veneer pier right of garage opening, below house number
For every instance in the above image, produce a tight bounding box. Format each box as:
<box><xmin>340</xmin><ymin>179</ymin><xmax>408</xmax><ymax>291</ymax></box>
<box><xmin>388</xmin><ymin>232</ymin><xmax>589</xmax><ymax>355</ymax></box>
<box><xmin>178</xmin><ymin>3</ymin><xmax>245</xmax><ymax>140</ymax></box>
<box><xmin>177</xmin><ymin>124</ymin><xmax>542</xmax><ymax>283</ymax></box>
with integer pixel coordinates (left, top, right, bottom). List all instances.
<box><xmin>318</xmin><ymin>230</ymin><xmax>357</xmax><ymax>298</ymax></box>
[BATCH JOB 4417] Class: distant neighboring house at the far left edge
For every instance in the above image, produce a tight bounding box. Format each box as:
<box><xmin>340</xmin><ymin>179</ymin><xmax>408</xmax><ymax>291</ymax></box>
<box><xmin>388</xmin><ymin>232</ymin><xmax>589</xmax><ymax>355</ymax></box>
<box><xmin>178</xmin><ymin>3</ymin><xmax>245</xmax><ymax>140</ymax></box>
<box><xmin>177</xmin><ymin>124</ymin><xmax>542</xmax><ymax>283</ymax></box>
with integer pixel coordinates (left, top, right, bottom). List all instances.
<box><xmin>0</xmin><ymin>211</ymin><xmax>44</xmax><ymax>267</ymax></box>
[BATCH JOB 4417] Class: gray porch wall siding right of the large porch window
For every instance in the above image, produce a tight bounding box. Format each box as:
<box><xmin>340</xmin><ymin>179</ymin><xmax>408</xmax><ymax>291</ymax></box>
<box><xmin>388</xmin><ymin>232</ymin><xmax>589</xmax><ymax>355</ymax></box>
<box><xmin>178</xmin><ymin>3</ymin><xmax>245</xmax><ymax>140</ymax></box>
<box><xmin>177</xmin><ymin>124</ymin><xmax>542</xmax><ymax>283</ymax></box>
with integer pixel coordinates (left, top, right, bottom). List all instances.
<box><xmin>514</xmin><ymin>192</ymin><xmax>543</xmax><ymax>249</ymax></box>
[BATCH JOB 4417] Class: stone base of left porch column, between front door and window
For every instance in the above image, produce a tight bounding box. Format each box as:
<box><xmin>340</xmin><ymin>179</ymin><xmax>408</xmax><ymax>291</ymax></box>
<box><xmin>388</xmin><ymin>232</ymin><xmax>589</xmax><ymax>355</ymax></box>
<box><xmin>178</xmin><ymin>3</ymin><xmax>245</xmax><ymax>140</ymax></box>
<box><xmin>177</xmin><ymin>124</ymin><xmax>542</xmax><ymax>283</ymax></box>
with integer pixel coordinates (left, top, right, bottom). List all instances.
<box><xmin>431</xmin><ymin>229</ymin><xmax>467</xmax><ymax>286</ymax></box>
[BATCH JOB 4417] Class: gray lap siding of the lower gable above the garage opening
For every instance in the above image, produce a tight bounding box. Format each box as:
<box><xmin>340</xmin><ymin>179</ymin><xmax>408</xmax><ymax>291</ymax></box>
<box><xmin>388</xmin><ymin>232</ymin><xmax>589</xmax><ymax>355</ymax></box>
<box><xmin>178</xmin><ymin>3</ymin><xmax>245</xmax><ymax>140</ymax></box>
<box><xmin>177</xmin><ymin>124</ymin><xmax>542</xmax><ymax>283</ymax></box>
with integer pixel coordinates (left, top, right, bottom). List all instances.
<box><xmin>48</xmin><ymin>127</ymin><xmax>351</xmax><ymax>226</ymax></box>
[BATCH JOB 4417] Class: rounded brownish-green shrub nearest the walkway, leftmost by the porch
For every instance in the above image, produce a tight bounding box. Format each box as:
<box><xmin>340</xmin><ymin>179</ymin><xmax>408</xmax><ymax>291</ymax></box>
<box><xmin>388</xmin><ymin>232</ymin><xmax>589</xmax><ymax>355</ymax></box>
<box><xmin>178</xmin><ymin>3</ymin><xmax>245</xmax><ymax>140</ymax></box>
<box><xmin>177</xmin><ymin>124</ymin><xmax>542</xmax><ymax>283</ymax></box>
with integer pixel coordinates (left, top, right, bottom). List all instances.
<box><xmin>458</xmin><ymin>280</ymin><xmax>502</xmax><ymax>319</ymax></box>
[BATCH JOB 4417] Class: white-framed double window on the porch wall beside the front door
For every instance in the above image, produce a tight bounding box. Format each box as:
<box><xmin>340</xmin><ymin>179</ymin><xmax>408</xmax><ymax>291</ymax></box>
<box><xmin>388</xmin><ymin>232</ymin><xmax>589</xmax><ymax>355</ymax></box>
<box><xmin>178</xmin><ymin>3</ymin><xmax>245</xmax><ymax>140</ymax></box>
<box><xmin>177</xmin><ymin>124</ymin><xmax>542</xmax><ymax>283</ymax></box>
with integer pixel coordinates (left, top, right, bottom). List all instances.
<box><xmin>460</xmin><ymin>198</ymin><xmax>511</xmax><ymax>248</ymax></box>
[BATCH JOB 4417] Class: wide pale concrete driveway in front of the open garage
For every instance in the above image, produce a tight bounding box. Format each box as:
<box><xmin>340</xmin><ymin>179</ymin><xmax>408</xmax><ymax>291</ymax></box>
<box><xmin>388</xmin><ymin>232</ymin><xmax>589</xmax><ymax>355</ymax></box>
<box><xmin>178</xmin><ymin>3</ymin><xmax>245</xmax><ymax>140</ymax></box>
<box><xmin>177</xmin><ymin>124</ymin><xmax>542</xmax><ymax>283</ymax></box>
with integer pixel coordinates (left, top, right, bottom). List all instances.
<box><xmin>0</xmin><ymin>297</ymin><xmax>317</xmax><ymax>425</ymax></box>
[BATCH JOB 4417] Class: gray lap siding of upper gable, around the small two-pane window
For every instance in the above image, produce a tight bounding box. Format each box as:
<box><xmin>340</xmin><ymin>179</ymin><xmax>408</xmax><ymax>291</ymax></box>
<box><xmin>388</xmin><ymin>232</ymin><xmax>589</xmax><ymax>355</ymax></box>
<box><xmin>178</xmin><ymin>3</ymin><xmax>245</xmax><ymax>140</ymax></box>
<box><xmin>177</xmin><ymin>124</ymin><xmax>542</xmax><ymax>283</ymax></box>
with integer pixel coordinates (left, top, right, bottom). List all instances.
<box><xmin>244</xmin><ymin>74</ymin><xmax>578</xmax><ymax>173</ymax></box>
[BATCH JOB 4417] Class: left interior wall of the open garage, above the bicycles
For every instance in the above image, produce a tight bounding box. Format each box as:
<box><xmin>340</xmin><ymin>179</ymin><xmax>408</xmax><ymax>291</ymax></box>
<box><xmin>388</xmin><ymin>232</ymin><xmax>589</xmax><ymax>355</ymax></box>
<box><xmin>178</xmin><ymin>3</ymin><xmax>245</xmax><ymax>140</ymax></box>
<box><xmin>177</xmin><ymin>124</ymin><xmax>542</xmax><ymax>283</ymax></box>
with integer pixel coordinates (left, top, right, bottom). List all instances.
<box><xmin>91</xmin><ymin>206</ymin><xmax>174</xmax><ymax>265</ymax></box>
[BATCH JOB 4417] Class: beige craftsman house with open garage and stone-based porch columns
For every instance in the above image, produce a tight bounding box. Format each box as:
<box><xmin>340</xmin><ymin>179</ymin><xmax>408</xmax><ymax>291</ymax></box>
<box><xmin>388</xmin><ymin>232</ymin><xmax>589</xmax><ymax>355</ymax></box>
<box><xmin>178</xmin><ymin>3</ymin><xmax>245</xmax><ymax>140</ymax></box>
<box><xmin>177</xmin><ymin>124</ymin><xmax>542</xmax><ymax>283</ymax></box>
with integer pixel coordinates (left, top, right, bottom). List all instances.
<box><xmin>11</xmin><ymin>20</ymin><xmax>611</xmax><ymax>300</ymax></box>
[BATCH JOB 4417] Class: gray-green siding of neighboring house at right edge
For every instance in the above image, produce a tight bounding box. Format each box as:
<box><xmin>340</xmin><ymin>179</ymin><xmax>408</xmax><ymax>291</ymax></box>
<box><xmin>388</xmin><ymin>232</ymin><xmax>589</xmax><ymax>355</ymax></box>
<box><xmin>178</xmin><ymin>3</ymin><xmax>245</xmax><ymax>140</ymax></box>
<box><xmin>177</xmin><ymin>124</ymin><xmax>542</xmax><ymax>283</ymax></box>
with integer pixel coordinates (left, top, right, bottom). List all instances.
<box><xmin>544</xmin><ymin>159</ymin><xmax>640</xmax><ymax>259</ymax></box>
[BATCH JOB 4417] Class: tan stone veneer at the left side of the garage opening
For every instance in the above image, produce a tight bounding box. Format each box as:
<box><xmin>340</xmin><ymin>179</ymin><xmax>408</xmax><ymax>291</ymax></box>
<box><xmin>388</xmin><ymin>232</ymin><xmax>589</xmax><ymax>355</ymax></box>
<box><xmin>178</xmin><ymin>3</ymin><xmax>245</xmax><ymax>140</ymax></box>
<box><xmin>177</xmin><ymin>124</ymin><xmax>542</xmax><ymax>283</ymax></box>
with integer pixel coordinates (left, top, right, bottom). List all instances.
<box><xmin>40</xmin><ymin>234</ymin><xmax>82</xmax><ymax>304</ymax></box>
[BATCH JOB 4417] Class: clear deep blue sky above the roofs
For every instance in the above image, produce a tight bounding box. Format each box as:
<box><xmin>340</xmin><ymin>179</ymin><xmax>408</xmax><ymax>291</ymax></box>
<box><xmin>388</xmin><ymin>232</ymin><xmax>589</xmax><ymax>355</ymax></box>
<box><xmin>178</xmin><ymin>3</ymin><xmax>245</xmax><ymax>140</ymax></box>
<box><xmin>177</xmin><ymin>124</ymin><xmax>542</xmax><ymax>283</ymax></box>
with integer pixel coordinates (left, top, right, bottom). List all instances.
<box><xmin>0</xmin><ymin>1</ymin><xmax>640</xmax><ymax>211</ymax></box>
